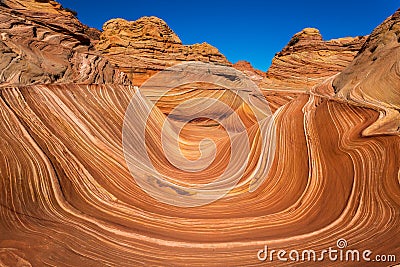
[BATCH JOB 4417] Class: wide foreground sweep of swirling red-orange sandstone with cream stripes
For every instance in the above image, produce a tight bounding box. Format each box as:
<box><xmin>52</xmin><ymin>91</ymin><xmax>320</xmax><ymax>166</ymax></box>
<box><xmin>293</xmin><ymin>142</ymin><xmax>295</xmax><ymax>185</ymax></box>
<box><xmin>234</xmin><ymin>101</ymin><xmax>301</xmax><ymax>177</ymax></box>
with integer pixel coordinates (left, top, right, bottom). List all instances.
<box><xmin>0</xmin><ymin>84</ymin><xmax>400</xmax><ymax>266</ymax></box>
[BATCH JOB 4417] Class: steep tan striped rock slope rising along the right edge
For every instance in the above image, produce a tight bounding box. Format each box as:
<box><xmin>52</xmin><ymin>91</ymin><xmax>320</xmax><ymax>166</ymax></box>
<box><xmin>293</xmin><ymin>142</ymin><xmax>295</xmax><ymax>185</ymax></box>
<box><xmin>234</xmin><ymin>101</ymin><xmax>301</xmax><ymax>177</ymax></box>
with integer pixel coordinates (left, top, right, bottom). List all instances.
<box><xmin>333</xmin><ymin>9</ymin><xmax>400</xmax><ymax>135</ymax></box>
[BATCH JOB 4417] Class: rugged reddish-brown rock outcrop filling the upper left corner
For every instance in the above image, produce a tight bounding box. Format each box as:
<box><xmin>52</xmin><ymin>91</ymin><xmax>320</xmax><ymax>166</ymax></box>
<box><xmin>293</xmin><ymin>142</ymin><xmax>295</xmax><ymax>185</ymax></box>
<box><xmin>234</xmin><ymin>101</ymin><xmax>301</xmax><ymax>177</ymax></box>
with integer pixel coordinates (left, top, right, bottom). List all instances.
<box><xmin>0</xmin><ymin>0</ymin><xmax>129</xmax><ymax>86</ymax></box>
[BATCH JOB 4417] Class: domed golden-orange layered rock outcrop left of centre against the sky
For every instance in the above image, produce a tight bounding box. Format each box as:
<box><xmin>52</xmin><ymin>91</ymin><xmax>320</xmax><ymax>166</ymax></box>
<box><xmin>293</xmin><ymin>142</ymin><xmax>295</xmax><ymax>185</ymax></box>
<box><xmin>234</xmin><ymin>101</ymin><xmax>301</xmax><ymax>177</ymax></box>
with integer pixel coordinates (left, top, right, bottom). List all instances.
<box><xmin>96</xmin><ymin>17</ymin><xmax>231</xmax><ymax>85</ymax></box>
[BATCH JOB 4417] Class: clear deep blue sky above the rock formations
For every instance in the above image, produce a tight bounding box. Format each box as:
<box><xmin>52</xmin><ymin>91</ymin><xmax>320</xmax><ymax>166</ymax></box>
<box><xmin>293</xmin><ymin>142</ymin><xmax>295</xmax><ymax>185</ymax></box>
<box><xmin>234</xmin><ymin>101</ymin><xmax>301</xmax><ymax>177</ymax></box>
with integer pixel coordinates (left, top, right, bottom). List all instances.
<box><xmin>59</xmin><ymin>0</ymin><xmax>400</xmax><ymax>71</ymax></box>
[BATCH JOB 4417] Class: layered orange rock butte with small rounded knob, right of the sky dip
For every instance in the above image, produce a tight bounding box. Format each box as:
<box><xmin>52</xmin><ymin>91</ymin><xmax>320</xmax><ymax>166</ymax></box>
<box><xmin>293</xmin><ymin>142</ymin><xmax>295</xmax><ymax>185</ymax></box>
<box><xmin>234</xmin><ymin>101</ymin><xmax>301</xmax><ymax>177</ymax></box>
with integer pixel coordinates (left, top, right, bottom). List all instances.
<box><xmin>262</xmin><ymin>28</ymin><xmax>366</xmax><ymax>90</ymax></box>
